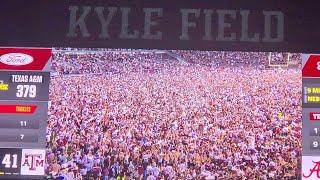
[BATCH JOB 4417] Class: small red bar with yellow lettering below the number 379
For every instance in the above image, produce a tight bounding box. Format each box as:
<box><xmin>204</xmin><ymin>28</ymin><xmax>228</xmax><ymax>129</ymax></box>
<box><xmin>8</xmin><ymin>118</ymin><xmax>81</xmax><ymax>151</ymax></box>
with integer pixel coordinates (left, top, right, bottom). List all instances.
<box><xmin>0</xmin><ymin>105</ymin><xmax>37</xmax><ymax>114</ymax></box>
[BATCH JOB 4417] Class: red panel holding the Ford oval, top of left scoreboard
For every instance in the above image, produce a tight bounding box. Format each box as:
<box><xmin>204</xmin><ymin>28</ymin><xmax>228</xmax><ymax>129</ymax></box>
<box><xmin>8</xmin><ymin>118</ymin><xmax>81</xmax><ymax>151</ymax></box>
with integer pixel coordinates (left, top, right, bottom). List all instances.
<box><xmin>0</xmin><ymin>48</ymin><xmax>52</xmax><ymax>71</ymax></box>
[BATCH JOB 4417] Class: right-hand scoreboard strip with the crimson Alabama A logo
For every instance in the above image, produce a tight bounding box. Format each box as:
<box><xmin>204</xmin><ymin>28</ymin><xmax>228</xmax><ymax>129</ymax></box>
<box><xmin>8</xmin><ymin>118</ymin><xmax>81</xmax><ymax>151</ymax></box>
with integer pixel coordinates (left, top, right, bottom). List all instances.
<box><xmin>302</xmin><ymin>54</ymin><xmax>320</xmax><ymax>179</ymax></box>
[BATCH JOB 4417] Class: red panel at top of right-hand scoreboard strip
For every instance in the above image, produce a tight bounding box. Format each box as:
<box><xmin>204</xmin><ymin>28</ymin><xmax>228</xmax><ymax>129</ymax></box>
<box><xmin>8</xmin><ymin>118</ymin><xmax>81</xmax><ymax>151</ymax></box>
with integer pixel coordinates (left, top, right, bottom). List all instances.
<box><xmin>302</xmin><ymin>55</ymin><xmax>320</xmax><ymax>77</ymax></box>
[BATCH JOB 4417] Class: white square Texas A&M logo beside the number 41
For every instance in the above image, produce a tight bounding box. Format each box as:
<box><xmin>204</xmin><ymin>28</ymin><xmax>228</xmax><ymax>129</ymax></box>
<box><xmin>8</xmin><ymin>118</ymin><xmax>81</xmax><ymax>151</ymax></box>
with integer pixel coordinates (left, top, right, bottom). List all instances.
<box><xmin>21</xmin><ymin>149</ymin><xmax>45</xmax><ymax>175</ymax></box>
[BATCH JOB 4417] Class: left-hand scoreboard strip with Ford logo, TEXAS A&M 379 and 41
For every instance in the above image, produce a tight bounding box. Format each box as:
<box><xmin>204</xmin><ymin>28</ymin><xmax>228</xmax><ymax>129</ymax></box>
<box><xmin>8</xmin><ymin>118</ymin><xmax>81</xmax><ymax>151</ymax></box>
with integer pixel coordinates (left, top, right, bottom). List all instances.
<box><xmin>0</xmin><ymin>48</ymin><xmax>52</xmax><ymax>179</ymax></box>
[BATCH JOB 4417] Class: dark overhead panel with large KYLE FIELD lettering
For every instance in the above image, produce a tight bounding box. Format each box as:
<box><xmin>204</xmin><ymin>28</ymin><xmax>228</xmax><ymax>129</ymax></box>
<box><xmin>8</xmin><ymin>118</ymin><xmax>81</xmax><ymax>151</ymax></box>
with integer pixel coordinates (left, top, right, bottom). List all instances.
<box><xmin>0</xmin><ymin>0</ymin><xmax>320</xmax><ymax>53</ymax></box>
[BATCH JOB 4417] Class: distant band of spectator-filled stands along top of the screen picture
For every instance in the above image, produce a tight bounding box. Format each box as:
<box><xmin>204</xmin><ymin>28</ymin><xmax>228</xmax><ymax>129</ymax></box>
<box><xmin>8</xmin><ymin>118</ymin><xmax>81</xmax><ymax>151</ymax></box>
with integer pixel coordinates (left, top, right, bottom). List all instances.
<box><xmin>52</xmin><ymin>48</ymin><xmax>301</xmax><ymax>74</ymax></box>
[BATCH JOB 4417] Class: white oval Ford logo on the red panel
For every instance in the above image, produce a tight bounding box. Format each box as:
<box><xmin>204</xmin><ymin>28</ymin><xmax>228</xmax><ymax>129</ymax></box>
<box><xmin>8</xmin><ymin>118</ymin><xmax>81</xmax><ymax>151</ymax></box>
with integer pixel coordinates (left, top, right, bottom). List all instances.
<box><xmin>0</xmin><ymin>53</ymin><xmax>33</xmax><ymax>66</ymax></box>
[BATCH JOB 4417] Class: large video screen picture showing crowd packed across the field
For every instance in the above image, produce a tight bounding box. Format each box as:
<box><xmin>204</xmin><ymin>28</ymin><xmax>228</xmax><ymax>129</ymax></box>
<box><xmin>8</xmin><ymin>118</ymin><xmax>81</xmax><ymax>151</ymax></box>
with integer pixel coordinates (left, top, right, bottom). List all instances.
<box><xmin>46</xmin><ymin>48</ymin><xmax>302</xmax><ymax>180</ymax></box>
